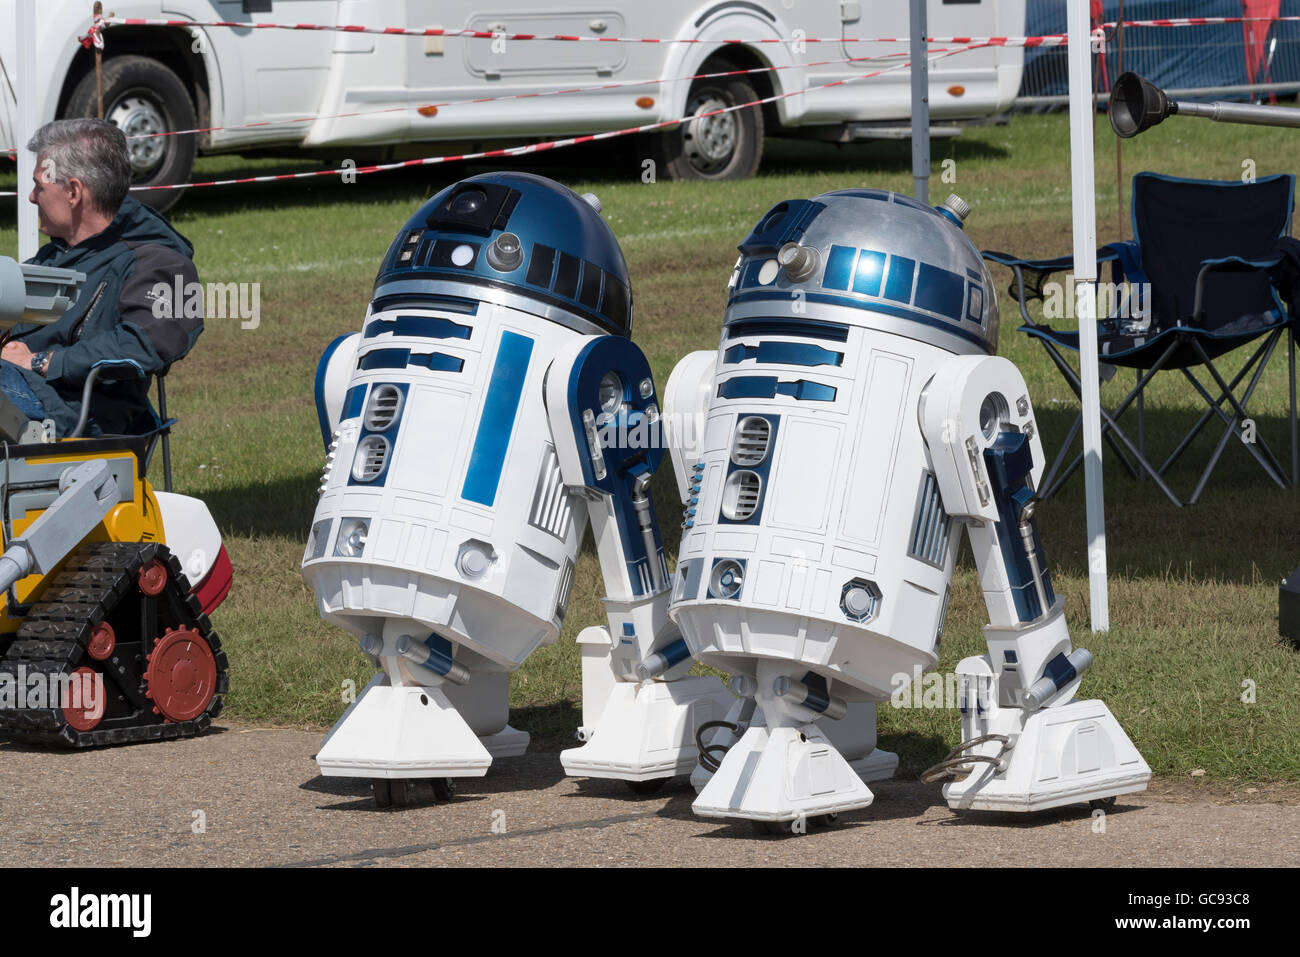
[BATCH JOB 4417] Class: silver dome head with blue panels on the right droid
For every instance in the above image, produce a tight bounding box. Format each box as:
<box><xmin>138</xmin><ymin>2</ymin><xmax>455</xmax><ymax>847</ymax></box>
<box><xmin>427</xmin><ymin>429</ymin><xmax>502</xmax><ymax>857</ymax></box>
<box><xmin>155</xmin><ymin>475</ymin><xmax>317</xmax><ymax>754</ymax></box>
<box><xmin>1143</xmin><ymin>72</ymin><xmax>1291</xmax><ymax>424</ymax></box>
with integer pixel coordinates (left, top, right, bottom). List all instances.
<box><xmin>727</xmin><ymin>189</ymin><xmax>997</xmax><ymax>354</ymax></box>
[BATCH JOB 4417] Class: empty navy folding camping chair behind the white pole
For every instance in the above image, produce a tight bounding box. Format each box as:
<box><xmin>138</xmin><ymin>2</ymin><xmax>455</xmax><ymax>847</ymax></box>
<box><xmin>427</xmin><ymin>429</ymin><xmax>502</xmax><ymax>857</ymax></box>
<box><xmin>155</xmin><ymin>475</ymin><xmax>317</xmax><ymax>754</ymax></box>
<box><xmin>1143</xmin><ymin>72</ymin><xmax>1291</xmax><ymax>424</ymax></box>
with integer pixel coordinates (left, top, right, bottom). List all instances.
<box><xmin>983</xmin><ymin>167</ymin><xmax>1300</xmax><ymax>506</ymax></box>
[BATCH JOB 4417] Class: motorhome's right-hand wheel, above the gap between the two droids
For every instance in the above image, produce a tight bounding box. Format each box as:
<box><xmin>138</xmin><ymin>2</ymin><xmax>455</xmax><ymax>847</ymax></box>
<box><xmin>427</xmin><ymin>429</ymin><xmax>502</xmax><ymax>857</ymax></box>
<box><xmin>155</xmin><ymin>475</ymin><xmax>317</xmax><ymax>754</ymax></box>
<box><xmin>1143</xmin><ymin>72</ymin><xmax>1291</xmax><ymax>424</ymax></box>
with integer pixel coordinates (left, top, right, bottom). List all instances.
<box><xmin>655</xmin><ymin>70</ymin><xmax>763</xmax><ymax>181</ymax></box>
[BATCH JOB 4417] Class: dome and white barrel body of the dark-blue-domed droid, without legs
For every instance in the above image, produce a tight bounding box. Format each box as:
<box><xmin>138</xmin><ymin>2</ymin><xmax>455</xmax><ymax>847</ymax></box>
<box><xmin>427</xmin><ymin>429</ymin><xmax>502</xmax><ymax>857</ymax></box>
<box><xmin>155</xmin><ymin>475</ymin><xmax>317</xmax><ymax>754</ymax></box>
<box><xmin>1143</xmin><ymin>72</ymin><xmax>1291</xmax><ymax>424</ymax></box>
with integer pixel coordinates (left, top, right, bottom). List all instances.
<box><xmin>303</xmin><ymin>173</ymin><xmax>632</xmax><ymax>766</ymax></box>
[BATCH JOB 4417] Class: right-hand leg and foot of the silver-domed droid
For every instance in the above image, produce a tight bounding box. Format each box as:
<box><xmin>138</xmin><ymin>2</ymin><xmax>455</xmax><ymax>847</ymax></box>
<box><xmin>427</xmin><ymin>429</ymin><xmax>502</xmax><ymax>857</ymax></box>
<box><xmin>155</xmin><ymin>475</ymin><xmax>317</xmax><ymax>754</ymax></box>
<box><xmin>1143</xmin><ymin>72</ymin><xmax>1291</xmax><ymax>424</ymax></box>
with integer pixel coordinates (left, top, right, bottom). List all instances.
<box><xmin>922</xmin><ymin>356</ymin><xmax>1151</xmax><ymax>811</ymax></box>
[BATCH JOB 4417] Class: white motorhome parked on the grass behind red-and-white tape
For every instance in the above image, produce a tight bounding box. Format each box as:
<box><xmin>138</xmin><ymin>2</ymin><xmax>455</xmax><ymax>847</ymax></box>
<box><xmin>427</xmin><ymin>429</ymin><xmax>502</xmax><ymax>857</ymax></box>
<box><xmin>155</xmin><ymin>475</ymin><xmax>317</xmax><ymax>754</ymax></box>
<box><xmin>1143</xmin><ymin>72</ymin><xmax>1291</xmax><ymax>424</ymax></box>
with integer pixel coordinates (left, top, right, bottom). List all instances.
<box><xmin>0</xmin><ymin>0</ymin><xmax>1024</xmax><ymax>205</ymax></box>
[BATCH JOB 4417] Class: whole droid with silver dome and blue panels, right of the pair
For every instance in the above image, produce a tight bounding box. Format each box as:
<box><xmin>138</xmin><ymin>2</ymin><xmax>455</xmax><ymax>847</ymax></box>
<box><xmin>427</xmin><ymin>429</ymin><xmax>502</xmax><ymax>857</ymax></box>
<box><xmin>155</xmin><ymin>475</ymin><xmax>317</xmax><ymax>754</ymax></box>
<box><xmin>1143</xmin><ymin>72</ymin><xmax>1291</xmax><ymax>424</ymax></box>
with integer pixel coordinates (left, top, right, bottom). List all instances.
<box><xmin>666</xmin><ymin>190</ymin><xmax>1151</xmax><ymax>827</ymax></box>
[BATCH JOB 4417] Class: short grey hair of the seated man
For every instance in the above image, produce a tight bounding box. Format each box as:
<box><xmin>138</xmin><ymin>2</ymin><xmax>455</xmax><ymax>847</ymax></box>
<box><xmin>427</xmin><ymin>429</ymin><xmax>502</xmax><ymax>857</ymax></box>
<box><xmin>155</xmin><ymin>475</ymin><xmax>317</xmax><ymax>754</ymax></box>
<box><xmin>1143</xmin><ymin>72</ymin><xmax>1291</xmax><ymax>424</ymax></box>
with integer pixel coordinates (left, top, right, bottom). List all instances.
<box><xmin>27</xmin><ymin>120</ymin><xmax>131</xmax><ymax>216</ymax></box>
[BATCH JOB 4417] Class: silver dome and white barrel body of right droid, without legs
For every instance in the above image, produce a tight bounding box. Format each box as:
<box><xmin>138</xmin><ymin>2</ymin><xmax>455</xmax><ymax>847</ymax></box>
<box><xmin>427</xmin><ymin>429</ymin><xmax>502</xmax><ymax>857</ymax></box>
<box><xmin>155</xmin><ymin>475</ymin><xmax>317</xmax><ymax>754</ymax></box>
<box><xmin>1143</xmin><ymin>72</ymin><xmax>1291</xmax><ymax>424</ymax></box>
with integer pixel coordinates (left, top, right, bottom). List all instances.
<box><xmin>668</xmin><ymin>190</ymin><xmax>1009</xmax><ymax>710</ymax></box>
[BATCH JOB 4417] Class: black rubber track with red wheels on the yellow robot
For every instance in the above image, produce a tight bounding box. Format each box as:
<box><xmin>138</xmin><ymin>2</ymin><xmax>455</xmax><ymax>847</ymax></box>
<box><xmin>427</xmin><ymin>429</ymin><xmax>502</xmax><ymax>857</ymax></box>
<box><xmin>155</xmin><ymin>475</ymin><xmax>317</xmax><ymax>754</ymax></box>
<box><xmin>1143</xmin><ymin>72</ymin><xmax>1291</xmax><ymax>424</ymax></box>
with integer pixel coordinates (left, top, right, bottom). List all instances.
<box><xmin>0</xmin><ymin>542</ymin><xmax>229</xmax><ymax>748</ymax></box>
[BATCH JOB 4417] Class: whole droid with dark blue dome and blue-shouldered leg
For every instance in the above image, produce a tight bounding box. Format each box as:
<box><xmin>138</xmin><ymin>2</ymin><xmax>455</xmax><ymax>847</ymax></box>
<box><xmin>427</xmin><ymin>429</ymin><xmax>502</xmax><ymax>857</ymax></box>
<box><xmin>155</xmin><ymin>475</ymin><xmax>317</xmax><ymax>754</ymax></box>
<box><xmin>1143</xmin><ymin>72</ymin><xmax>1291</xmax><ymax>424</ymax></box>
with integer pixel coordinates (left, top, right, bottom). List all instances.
<box><xmin>303</xmin><ymin>173</ymin><xmax>729</xmax><ymax>804</ymax></box>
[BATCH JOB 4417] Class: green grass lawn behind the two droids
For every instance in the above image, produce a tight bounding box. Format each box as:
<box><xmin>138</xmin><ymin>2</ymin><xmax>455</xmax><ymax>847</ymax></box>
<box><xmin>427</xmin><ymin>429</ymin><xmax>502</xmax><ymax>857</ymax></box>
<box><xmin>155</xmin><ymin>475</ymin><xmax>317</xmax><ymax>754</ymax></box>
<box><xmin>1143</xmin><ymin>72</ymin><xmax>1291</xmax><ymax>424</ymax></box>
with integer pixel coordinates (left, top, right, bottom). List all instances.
<box><xmin>0</xmin><ymin>113</ymin><xmax>1300</xmax><ymax>783</ymax></box>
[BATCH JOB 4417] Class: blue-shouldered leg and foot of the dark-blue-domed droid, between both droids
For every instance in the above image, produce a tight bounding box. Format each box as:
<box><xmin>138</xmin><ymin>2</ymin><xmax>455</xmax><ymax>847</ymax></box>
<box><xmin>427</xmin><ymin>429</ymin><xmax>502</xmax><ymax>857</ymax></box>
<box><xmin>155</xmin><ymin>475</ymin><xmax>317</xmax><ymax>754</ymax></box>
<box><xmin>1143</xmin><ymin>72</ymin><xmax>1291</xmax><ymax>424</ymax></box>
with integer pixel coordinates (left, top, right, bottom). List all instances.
<box><xmin>546</xmin><ymin>335</ymin><xmax>732</xmax><ymax>791</ymax></box>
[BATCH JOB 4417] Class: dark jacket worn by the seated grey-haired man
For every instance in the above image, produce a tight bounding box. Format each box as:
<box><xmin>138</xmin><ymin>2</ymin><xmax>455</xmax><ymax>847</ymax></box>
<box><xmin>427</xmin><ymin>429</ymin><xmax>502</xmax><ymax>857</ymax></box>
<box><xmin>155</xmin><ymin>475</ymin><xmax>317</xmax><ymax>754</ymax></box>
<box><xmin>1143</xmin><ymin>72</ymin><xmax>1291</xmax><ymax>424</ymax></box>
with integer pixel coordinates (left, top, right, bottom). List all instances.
<box><xmin>14</xmin><ymin>196</ymin><xmax>203</xmax><ymax>436</ymax></box>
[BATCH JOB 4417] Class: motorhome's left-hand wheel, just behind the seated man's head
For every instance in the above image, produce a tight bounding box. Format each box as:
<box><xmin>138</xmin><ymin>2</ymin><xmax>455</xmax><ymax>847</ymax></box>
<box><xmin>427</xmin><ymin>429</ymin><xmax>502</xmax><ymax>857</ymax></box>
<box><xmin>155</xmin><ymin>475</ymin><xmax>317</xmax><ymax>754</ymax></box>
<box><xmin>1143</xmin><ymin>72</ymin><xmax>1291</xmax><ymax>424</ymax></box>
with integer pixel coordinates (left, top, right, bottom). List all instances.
<box><xmin>64</xmin><ymin>55</ymin><xmax>199</xmax><ymax>211</ymax></box>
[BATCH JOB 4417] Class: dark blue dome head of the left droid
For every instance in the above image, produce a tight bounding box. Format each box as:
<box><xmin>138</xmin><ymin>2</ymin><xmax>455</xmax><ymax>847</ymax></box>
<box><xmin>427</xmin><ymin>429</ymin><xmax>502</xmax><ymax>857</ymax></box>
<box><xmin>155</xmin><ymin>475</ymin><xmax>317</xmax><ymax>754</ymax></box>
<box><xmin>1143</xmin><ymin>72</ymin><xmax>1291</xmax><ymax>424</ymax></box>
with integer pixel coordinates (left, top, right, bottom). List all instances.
<box><xmin>374</xmin><ymin>173</ymin><xmax>632</xmax><ymax>335</ymax></box>
